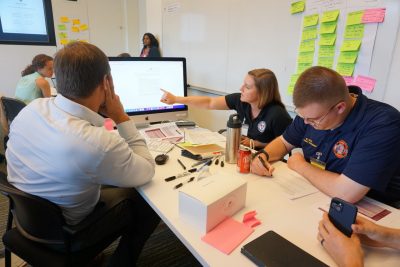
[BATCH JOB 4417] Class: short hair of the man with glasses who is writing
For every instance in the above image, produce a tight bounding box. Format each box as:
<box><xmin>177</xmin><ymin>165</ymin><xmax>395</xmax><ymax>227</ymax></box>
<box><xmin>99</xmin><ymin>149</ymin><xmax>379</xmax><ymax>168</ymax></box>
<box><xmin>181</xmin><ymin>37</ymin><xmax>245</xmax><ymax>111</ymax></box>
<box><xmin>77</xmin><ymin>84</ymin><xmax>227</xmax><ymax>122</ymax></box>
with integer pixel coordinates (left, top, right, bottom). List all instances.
<box><xmin>293</xmin><ymin>66</ymin><xmax>349</xmax><ymax>108</ymax></box>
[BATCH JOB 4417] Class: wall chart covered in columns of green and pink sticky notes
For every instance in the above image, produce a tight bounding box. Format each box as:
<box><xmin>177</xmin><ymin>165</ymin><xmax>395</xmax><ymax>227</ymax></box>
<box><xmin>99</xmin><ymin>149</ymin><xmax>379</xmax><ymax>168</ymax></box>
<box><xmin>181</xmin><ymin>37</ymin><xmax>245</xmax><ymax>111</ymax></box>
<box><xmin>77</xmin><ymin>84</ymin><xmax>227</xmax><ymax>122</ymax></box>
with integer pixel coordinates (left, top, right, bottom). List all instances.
<box><xmin>288</xmin><ymin>0</ymin><xmax>395</xmax><ymax>94</ymax></box>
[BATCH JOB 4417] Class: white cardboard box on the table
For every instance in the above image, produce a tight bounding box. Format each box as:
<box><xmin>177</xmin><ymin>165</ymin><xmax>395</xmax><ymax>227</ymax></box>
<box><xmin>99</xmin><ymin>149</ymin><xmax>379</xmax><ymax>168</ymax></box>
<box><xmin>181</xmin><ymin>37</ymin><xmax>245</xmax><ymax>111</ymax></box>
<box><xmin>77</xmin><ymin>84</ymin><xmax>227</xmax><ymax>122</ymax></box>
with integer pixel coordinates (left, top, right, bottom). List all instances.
<box><xmin>179</xmin><ymin>174</ymin><xmax>247</xmax><ymax>234</ymax></box>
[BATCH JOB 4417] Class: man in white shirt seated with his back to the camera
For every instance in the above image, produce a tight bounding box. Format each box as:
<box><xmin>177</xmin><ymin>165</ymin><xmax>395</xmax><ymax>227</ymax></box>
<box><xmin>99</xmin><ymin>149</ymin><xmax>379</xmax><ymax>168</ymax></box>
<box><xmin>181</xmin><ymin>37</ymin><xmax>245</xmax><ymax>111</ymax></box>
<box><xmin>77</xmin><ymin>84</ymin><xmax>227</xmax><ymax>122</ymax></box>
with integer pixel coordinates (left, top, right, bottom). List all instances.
<box><xmin>6</xmin><ymin>42</ymin><xmax>159</xmax><ymax>266</ymax></box>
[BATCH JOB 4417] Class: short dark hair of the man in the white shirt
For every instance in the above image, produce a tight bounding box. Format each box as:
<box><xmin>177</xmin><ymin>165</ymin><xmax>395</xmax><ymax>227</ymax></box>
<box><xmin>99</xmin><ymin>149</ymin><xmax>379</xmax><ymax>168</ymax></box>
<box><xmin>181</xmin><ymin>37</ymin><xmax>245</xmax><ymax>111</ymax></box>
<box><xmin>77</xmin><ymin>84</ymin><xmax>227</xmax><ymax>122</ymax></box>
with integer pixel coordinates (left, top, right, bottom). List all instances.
<box><xmin>54</xmin><ymin>42</ymin><xmax>110</xmax><ymax>99</ymax></box>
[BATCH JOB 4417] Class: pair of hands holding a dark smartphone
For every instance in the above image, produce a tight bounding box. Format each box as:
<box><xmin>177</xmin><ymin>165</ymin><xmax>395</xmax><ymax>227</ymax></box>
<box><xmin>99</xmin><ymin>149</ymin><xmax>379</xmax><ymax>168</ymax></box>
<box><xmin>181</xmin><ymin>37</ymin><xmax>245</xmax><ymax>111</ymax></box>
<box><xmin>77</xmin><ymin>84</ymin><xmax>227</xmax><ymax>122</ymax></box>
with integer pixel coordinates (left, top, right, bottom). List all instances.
<box><xmin>317</xmin><ymin>213</ymin><xmax>400</xmax><ymax>267</ymax></box>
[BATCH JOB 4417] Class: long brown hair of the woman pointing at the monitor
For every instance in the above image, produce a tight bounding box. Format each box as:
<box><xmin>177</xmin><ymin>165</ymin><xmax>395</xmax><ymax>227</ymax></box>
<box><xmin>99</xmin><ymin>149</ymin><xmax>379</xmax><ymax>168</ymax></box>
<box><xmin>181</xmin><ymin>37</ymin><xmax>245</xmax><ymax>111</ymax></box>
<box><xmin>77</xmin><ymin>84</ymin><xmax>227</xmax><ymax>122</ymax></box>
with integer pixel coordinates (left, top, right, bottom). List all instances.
<box><xmin>248</xmin><ymin>69</ymin><xmax>285</xmax><ymax>108</ymax></box>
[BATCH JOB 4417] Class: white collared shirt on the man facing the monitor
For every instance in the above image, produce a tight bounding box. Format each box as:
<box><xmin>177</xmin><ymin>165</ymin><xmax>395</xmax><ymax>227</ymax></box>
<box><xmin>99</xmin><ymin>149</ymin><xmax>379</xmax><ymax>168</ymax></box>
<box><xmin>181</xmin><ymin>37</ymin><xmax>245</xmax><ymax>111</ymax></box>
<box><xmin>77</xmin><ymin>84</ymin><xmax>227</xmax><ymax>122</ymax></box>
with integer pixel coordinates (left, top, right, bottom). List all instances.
<box><xmin>6</xmin><ymin>95</ymin><xmax>155</xmax><ymax>224</ymax></box>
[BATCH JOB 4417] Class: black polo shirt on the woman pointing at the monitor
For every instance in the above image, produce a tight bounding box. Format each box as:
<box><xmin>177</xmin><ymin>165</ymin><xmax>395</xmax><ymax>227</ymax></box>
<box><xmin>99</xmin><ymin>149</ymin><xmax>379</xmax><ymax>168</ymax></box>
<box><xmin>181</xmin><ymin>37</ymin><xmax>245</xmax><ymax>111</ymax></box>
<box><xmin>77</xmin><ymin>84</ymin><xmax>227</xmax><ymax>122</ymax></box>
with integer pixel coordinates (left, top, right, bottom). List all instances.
<box><xmin>225</xmin><ymin>93</ymin><xmax>292</xmax><ymax>143</ymax></box>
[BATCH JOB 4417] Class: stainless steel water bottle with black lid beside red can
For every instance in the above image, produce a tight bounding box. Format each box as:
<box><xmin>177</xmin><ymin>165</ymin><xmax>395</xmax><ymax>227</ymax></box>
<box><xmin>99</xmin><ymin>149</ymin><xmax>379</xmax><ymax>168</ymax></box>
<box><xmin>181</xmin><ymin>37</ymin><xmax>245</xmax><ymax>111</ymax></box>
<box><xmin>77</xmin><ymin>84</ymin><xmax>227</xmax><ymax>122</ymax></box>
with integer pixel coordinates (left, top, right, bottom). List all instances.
<box><xmin>225</xmin><ymin>114</ymin><xmax>242</xmax><ymax>163</ymax></box>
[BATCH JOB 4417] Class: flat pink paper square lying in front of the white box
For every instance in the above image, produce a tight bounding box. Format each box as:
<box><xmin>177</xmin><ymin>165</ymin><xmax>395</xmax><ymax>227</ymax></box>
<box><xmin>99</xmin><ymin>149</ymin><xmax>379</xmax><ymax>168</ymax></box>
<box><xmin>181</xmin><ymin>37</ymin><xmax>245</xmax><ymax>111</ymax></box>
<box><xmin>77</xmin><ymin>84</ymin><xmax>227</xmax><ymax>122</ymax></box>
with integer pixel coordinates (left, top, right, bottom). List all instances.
<box><xmin>201</xmin><ymin>218</ymin><xmax>254</xmax><ymax>255</ymax></box>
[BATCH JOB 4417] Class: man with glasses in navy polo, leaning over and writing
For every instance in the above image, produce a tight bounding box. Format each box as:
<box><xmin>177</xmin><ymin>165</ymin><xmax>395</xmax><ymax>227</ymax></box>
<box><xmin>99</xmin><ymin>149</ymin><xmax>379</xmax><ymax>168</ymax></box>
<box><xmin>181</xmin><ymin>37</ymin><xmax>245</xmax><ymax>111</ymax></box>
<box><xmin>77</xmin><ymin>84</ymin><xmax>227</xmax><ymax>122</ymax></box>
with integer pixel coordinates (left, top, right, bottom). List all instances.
<box><xmin>251</xmin><ymin>67</ymin><xmax>400</xmax><ymax>203</ymax></box>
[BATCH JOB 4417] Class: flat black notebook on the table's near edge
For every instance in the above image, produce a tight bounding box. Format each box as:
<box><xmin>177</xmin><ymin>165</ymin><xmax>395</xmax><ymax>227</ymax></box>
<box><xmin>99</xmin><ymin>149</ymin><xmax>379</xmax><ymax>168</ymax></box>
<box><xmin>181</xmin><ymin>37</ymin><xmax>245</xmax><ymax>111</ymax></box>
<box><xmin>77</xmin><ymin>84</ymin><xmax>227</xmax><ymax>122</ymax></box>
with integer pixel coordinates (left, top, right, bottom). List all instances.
<box><xmin>241</xmin><ymin>231</ymin><xmax>328</xmax><ymax>267</ymax></box>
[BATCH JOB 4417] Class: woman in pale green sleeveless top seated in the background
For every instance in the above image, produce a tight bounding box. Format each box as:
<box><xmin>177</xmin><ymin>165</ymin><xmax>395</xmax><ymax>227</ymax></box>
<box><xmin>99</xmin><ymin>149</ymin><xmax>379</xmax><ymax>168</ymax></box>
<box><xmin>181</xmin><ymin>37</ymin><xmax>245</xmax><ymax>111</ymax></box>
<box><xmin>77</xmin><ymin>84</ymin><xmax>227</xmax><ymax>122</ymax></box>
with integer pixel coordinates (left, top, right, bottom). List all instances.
<box><xmin>15</xmin><ymin>54</ymin><xmax>53</xmax><ymax>104</ymax></box>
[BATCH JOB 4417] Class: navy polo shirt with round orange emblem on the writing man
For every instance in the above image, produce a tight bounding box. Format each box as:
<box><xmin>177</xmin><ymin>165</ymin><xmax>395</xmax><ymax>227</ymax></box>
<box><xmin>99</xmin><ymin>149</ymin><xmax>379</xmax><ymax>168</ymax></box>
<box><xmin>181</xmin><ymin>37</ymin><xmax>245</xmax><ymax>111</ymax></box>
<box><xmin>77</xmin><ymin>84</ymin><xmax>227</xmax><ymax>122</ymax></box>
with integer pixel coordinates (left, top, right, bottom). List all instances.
<box><xmin>283</xmin><ymin>86</ymin><xmax>400</xmax><ymax>194</ymax></box>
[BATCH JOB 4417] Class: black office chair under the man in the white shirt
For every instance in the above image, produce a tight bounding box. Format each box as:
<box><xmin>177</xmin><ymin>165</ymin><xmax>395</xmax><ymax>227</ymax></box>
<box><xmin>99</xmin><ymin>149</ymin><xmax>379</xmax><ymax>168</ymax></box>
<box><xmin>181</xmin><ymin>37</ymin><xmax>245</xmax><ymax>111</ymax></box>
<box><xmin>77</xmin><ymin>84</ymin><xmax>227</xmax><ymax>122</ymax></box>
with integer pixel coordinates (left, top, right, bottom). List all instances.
<box><xmin>0</xmin><ymin>172</ymin><xmax>120</xmax><ymax>267</ymax></box>
